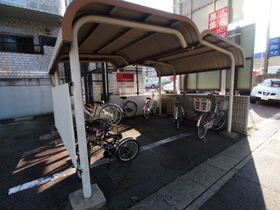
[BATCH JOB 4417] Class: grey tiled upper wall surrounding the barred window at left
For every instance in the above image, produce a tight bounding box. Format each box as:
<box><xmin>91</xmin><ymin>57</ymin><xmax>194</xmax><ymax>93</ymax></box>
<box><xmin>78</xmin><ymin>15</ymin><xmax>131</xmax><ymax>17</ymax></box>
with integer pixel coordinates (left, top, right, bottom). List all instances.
<box><xmin>0</xmin><ymin>18</ymin><xmax>59</xmax><ymax>78</ymax></box>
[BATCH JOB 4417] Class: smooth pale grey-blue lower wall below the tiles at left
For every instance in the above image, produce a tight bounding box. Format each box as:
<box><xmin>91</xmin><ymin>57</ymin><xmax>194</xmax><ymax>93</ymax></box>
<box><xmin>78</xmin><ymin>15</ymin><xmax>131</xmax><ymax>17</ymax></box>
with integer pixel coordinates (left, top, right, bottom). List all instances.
<box><xmin>0</xmin><ymin>86</ymin><xmax>53</xmax><ymax>120</ymax></box>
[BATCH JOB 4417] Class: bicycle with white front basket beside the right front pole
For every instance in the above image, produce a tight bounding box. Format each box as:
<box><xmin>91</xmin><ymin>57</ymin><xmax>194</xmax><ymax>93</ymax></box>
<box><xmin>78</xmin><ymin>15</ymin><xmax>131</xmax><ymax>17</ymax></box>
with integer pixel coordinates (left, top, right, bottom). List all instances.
<box><xmin>194</xmin><ymin>94</ymin><xmax>228</xmax><ymax>139</ymax></box>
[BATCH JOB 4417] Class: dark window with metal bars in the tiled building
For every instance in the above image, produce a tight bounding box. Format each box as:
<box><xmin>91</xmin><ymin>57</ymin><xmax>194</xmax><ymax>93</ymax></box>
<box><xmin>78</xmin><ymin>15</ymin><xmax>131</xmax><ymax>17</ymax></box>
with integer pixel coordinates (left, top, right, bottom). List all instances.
<box><xmin>0</xmin><ymin>34</ymin><xmax>43</xmax><ymax>54</ymax></box>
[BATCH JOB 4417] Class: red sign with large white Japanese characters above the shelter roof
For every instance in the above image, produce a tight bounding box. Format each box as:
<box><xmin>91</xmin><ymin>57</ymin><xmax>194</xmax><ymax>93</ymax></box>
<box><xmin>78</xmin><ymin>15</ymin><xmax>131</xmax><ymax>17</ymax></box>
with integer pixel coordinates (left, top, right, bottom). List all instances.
<box><xmin>208</xmin><ymin>6</ymin><xmax>228</xmax><ymax>38</ymax></box>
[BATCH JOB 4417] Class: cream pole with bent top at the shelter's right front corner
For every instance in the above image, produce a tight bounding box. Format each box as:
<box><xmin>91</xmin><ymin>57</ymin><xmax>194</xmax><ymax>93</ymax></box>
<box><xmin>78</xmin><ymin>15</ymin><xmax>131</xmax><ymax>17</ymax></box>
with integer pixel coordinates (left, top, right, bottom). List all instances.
<box><xmin>202</xmin><ymin>40</ymin><xmax>235</xmax><ymax>133</ymax></box>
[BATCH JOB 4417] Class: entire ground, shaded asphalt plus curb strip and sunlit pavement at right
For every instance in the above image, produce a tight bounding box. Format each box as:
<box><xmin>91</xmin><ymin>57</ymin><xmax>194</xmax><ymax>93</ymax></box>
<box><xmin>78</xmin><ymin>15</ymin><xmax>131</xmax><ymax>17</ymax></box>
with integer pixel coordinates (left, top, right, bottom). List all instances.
<box><xmin>0</xmin><ymin>101</ymin><xmax>280</xmax><ymax>210</ymax></box>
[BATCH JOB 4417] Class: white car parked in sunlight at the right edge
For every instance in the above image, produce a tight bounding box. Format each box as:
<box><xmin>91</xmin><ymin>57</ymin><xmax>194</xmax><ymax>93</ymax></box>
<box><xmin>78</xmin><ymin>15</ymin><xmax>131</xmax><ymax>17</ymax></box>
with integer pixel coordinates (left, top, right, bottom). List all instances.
<box><xmin>250</xmin><ymin>79</ymin><xmax>280</xmax><ymax>103</ymax></box>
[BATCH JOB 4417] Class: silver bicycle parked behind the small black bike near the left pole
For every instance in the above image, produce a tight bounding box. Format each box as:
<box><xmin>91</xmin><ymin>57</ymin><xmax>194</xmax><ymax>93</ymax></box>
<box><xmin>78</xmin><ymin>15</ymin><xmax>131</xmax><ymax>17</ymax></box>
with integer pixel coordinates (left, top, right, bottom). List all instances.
<box><xmin>84</xmin><ymin>101</ymin><xmax>123</xmax><ymax>124</ymax></box>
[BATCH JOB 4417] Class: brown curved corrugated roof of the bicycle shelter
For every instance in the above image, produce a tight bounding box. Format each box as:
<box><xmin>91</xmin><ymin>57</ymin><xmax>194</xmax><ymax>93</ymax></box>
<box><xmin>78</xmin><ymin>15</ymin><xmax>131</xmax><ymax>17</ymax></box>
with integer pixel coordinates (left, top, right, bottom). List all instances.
<box><xmin>50</xmin><ymin>0</ymin><xmax>245</xmax><ymax>75</ymax></box>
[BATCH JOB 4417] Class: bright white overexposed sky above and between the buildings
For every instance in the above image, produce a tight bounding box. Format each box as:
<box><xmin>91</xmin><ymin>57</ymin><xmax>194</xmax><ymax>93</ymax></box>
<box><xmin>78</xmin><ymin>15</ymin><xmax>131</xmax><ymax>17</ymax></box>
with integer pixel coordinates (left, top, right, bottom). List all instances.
<box><xmin>126</xmin><ymin>0</ymin><xmax>280</xmax><ymax>53</ymax></box>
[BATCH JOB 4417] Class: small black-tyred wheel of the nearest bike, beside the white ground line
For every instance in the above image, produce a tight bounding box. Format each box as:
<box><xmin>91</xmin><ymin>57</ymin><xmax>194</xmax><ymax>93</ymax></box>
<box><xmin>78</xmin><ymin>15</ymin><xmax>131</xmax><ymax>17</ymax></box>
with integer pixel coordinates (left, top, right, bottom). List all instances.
<box><xmin>116</xmin><ymin>138</ymin><xmax>139</xmax><ymax>162</ymax></box>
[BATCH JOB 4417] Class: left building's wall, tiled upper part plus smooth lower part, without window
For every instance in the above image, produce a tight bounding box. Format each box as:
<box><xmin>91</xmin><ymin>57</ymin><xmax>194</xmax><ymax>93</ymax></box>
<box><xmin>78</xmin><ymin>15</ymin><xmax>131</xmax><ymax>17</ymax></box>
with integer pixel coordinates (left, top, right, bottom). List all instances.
<box><xmin>0</xmin><ymin>17</ymin><xmax>59</xmax><ymax>120</ymax></box>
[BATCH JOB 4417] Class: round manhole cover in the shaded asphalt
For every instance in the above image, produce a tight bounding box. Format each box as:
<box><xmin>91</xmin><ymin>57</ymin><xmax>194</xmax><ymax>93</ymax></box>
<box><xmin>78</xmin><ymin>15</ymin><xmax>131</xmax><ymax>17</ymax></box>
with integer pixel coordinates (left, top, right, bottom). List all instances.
<box><xmin>160</xmin><ymin>152</ymin><xmax>189</xmax><ymax>169</ymax></box>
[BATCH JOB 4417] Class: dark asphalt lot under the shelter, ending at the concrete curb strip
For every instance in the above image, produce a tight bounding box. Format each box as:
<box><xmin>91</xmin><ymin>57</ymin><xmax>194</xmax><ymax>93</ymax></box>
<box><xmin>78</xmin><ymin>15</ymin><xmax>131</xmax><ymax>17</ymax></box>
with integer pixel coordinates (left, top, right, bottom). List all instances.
<box><xmin>0</xmin><ymin>115</ymin><xmax>247</xmax><ymax>209</ymax></box>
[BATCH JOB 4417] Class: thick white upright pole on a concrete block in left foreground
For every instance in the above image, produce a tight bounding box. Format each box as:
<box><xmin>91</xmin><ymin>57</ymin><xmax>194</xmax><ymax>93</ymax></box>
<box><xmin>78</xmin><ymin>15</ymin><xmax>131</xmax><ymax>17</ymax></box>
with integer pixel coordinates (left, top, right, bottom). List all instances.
<box><xmin>69</xmin><ymin>24</ymin><xmax>92</xmax><ymax>198</ymax></box>
